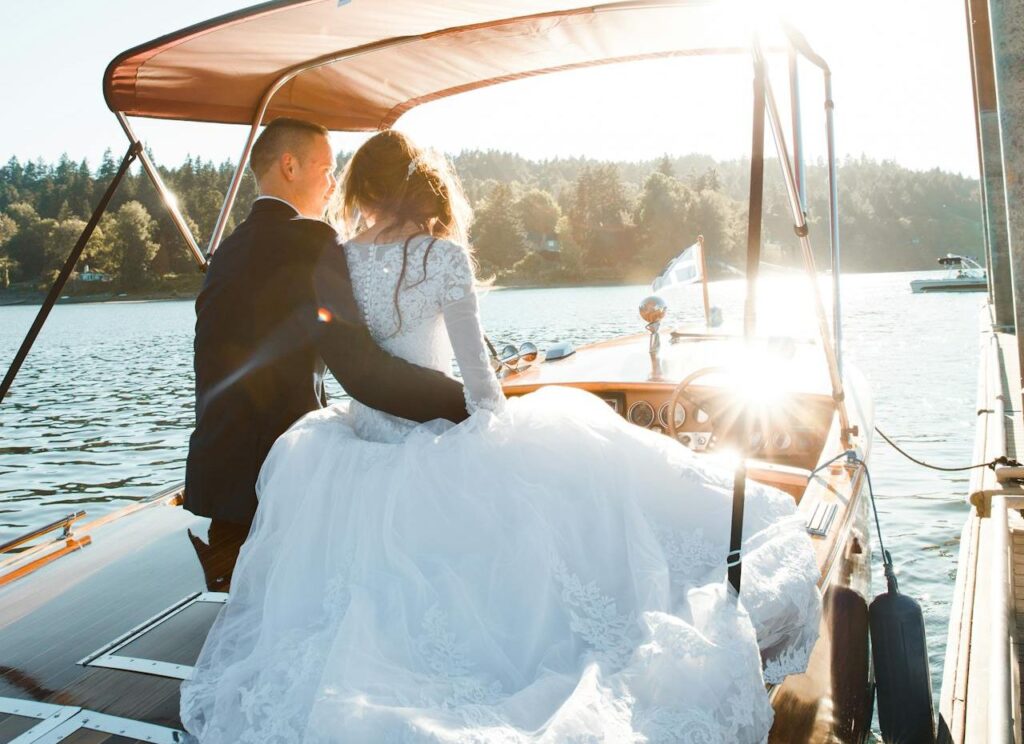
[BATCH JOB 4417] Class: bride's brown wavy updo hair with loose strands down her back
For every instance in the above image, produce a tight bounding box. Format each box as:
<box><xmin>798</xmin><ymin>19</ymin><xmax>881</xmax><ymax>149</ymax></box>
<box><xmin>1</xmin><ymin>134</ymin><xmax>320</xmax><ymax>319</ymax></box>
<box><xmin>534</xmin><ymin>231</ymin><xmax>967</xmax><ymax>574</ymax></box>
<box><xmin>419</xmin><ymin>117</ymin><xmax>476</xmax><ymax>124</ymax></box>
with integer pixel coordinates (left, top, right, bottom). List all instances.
<box><xmin>335</xmin><ymin>129</ymin><xmax>473</xmax><ymax>333</ymax></box>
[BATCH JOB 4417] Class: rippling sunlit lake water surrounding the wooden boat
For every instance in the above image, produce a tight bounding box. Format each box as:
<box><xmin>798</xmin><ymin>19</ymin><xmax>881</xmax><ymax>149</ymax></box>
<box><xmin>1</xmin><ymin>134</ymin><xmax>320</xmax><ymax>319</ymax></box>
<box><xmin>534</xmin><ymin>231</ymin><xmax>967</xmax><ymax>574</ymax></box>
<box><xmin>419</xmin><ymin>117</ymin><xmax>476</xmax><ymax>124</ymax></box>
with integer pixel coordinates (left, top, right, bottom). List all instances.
<box><xmin>0</xmin><ymin>272</ymin><xmax>984</xmax><ymax>720</ymax></box>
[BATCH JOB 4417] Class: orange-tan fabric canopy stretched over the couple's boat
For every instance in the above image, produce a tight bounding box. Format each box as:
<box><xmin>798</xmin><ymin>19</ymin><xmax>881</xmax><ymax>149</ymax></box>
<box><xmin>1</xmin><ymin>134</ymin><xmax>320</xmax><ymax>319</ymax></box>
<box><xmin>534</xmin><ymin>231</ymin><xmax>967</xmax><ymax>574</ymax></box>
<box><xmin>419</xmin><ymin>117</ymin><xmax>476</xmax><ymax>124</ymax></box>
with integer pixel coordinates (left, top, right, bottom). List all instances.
<box><xmin>103</xmin><ymin>0</ymin><xmax>806</xmax><ymax>131</ymax></box>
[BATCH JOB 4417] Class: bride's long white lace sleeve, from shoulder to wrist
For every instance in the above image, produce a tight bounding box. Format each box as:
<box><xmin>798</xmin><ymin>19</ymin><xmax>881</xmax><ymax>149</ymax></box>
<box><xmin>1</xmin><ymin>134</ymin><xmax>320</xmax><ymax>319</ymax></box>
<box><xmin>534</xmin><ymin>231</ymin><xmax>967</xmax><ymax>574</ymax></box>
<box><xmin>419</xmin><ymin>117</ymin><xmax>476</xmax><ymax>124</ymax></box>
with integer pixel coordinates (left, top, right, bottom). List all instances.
<box><xmin>435</xmin><ymin>243</ymin><xmax>505</xmax><ymax>413</ymax></box>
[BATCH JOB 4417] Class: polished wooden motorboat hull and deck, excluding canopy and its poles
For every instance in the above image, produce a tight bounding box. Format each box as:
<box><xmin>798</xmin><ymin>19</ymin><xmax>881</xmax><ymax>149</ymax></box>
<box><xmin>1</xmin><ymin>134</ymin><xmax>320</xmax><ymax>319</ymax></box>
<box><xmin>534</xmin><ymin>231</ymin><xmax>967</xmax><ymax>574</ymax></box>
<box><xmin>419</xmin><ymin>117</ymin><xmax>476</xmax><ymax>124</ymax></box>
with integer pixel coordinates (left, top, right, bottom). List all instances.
<box><xmin>0</xmin><ymin>331</ymin><xmax>872</xmax><ymax>742</ymax></box>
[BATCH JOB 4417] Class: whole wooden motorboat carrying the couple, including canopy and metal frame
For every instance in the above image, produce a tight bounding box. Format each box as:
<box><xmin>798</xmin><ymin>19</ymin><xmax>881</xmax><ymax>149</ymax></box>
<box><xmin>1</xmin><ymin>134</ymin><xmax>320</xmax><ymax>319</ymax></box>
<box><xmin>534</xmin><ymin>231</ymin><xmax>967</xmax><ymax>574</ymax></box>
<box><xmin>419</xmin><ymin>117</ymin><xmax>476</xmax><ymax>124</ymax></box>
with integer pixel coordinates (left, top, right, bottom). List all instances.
<box><xmin>0</xmin><ymin>0</ymin><xmax>873</xmax><ymax>743</ymax></box>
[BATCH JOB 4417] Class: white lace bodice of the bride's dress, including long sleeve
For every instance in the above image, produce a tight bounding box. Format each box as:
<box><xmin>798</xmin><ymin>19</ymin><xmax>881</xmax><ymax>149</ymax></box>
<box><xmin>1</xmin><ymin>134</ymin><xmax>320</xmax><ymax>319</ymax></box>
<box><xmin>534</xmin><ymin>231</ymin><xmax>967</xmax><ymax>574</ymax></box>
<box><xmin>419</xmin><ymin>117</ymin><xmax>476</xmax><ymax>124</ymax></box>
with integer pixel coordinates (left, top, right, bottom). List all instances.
<box><xmin>345</xmin><ymin>235</ymin><xmax>505</xmax><ymax>442</ymax></box>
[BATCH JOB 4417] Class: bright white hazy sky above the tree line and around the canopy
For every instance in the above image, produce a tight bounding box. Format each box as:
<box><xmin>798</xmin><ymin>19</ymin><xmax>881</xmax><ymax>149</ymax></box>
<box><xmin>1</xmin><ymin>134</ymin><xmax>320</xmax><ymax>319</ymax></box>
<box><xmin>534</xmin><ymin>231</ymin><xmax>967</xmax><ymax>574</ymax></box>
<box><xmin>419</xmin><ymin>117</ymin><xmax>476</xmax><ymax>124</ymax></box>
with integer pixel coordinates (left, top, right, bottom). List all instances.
<box><xmin>0</xmin><ymin>0</ymin><xmax>978</xmax><ymax>177</ymax></box>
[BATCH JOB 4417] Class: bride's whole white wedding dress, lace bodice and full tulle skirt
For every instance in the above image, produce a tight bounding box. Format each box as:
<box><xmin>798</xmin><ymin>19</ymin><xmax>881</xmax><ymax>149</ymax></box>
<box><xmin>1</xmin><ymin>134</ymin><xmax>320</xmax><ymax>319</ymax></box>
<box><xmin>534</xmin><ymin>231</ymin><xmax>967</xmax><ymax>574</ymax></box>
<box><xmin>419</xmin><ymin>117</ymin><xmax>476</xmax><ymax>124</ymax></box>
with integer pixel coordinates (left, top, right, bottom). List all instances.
<box><xmin>181</xmin><ymin>238</ymin><xmax>820</xmax><ymax>744</ymax></box>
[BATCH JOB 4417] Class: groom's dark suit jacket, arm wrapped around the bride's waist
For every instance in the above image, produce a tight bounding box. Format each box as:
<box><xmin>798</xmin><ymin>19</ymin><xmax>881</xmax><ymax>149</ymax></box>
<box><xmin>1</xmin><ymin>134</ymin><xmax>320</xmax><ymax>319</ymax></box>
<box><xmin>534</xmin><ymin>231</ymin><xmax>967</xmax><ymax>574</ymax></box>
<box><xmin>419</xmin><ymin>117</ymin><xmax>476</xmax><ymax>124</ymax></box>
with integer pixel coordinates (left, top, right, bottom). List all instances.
<box><xmin>184</xmin><ymin>199</ymin><xmax>466</xmax><ymax>524</ymax></box>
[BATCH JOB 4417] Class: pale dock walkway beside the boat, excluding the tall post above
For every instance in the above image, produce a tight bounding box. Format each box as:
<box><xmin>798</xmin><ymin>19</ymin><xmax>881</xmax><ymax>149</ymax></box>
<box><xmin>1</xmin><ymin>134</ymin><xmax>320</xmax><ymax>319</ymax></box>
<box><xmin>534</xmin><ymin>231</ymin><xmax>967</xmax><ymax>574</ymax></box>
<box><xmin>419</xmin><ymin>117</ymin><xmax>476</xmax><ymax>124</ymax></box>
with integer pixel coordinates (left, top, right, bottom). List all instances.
<box><xmin>938</xmin><ymin>323</ymin><xmax>1024</xmax><ymax>744</ymax></box>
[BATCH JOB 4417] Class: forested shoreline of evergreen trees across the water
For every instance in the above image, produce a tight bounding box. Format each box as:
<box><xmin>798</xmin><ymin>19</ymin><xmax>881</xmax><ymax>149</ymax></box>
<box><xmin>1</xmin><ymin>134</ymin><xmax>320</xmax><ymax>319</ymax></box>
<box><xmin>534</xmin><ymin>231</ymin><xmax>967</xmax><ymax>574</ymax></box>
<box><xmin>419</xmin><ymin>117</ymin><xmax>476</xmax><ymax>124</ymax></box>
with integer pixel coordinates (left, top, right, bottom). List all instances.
<box><xmin>0</xmin><ymin>150</ymin><xmax>982</xmax><ymax>301</ymax></box>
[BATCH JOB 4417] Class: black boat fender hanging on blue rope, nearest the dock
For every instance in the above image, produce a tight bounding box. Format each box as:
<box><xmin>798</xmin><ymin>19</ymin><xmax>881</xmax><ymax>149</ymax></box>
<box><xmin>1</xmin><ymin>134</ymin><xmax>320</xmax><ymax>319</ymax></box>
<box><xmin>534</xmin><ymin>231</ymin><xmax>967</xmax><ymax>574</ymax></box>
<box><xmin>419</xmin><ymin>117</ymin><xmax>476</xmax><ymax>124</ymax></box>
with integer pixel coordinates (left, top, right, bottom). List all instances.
<box><xmin>868</xmin><ymin>551</ymin><xmax>935</xmax><ymax>744</ymax></box>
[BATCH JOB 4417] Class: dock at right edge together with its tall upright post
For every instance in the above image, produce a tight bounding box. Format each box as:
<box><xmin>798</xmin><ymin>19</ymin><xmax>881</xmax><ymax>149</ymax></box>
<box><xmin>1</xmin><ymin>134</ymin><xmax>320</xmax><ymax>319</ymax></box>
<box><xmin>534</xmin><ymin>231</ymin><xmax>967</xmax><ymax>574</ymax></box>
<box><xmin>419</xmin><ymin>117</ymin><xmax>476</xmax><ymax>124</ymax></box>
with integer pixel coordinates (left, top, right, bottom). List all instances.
<box><xmin>937</xmin><ymin>0</ymin><xmax>1024</xmax><ymax>744</ymax></box>
